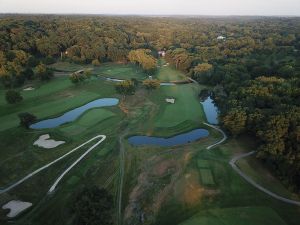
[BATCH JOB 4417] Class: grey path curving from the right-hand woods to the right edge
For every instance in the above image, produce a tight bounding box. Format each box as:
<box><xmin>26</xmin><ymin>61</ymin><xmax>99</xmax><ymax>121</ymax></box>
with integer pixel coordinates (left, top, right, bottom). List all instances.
<box><xmin>229</xmin><ymin>151</ymin><xmax>300</xmax><ymax>206</ymax></box>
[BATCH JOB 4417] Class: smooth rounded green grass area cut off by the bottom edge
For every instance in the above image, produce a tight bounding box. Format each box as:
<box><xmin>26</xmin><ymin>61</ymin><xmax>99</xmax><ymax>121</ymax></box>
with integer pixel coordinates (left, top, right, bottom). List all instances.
<box><xmin>180</xmin><ymin>207</ymin><xmax>286</xmax><ymax>225</ymax></box>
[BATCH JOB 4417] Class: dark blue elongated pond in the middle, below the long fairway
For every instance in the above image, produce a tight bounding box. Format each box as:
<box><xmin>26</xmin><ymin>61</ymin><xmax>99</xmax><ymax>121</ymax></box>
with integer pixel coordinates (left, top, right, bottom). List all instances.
<box><xmin>128</xmin><ymin>129</ymin><xmax>209</xmax><ymax>147</ymax></box>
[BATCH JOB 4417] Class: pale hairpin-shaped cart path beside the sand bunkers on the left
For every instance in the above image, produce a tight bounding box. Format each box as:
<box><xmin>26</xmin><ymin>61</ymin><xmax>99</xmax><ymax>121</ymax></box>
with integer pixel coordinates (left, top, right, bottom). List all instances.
<box><xmin>0</xmin><ymin>135</ymin><xmax>106</xmax><ymax>194</ymax></box>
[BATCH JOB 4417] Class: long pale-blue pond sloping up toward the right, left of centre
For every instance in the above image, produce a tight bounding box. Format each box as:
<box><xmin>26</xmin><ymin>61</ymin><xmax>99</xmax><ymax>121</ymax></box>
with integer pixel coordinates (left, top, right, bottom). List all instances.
<box><xmin>30</xmin><ymin>98</ymin><xmax>119</xmax><ymax>129</ymax></box>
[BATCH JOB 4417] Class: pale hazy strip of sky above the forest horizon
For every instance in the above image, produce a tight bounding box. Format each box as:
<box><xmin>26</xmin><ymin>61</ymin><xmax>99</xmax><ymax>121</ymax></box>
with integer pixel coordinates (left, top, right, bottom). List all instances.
<box><xmin>0</xmin><ymin>0</ymin><xmax>300</xmax><ymax>16</ymax></box>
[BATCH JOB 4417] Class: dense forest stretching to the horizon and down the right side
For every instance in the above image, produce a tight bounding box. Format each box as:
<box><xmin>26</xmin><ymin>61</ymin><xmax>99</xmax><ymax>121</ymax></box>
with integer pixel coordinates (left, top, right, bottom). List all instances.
<box><xmin>0</xmin><ymin>15</ymin><xmax>300</xmax><ymax>191</ymax></box>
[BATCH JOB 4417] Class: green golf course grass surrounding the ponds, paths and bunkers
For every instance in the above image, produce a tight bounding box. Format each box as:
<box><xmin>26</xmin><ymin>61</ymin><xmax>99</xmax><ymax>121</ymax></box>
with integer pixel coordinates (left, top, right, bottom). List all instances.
<box><xmin>0</xmin><ymin>61</ymin><xmax>300</xmax><ymax>225</ymax></box>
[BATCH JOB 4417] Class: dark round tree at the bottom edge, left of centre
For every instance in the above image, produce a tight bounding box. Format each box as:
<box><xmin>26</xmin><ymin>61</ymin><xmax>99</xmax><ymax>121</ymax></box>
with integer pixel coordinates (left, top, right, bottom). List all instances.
<box><xmin>72</xmin><ymin>186</ymin><xmax>113</xmax><ymax>225</ymax></box>
